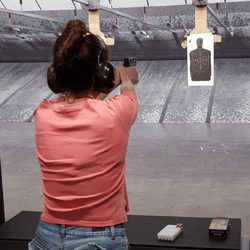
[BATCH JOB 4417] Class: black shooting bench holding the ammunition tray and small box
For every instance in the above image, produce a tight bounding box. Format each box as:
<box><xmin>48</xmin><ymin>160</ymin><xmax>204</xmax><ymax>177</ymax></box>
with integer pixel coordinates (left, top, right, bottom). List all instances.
<box><xmin>0</xmin><ymin>158</ymin><xmax>244</xmax><ymax>250</ymax></box>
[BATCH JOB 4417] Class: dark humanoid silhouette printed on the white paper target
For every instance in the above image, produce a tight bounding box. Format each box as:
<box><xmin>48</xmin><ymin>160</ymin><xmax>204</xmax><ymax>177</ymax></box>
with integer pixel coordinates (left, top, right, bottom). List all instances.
<box><xmin>190</xmin><ymin>38</ymin><xmax>211</xmax><ymax>81</ymax></box>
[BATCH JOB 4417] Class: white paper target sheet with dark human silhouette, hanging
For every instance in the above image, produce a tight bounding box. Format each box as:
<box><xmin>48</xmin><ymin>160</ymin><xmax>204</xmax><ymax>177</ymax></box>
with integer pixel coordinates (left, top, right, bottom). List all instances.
<box><xmin>188</xmin><ymin>33</ymin><xmax>214</xmax><ymax>86</ymax></box>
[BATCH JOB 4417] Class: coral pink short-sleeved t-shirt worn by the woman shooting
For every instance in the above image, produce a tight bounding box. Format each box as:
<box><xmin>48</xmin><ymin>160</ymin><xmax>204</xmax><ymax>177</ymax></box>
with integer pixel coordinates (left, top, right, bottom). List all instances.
<box><xmin>34</xmin><ymin>92</ymin><xmax>139</xmax><ymax>227</ymax></box>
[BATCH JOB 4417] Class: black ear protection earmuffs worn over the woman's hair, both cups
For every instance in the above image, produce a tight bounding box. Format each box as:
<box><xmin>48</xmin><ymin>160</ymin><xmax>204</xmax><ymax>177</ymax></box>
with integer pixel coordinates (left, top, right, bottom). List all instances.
<box><xmin>47</xmin><ymin>36</ymin><xmax>116</xmax><ymax>94</ymax></box>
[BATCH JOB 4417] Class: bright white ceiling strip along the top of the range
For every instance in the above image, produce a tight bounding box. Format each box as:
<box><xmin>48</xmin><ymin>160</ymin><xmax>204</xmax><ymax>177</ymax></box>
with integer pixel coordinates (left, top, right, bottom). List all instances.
<box><xmin>0</xmin><ymin>0</ymin><xmax>250</xmax><ymax>11</ymax></box>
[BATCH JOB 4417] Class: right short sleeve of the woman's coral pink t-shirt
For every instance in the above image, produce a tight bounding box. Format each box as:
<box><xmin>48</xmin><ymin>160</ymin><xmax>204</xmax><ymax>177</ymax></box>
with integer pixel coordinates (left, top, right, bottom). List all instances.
<box><xmin>105</xmin><ymin>91</ymin><xmax>139</xmax><ymax>132</ymax></box>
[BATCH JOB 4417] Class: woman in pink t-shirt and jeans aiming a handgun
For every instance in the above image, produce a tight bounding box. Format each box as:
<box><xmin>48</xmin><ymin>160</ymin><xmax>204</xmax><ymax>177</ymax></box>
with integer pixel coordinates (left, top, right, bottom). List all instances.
<box><xmin>29</xmin><ymin>20</ymin><xmax>139</xmax><ymax>250</ymax></box>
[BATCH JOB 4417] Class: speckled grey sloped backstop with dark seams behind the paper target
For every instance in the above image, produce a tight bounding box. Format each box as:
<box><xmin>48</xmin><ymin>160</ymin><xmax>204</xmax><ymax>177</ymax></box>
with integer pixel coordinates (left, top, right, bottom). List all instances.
<box><xmin>0</xmin><ymin>58</ymin><xmax>250</xmax><ymax>124</ymax></box>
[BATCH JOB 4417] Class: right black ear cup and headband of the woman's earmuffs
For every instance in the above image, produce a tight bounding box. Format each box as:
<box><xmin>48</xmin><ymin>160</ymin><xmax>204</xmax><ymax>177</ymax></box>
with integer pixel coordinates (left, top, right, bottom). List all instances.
<box><xmin>93</xmin><ymin>37</ymin><xmax>116</xmax><ymax>94</ymax></box>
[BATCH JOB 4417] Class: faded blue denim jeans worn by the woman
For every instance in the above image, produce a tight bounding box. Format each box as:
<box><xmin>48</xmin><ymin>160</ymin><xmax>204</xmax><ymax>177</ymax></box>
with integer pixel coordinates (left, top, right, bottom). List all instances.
<box><xmin>29</xmin><ymin>219</ymin><xmax>131</xmax><ymax>250</ymax></box>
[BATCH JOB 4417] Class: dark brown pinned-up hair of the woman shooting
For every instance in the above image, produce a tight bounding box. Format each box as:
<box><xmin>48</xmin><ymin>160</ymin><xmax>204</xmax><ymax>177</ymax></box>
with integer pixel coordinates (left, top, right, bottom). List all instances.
<box><xmin>47</xmin><ymin>19</ymin><xmax>110</xmax><ymax>97</ymax></box>
